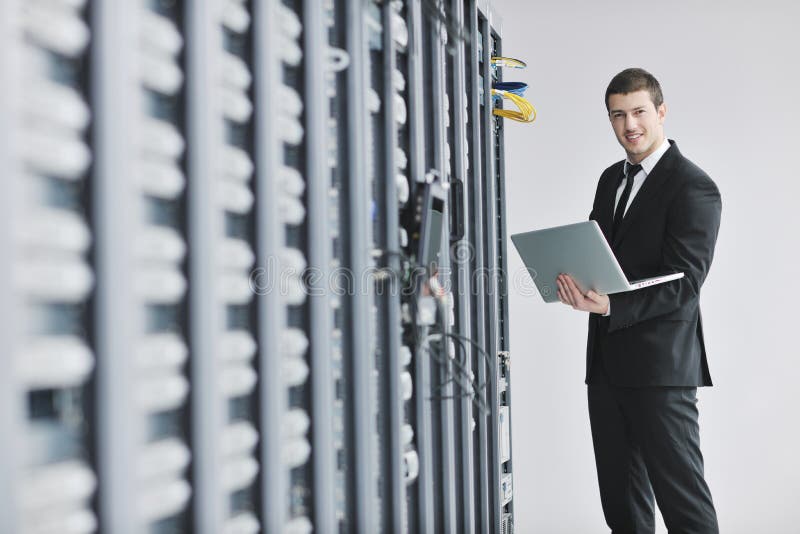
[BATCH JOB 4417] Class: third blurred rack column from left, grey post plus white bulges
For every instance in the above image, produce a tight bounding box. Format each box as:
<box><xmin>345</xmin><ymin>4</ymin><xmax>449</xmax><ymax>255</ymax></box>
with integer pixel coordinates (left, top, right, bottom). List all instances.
<box><xmin>186</xmin><ymin>0</ymin><xmax>264</xmax><ymax>532</ymax></box>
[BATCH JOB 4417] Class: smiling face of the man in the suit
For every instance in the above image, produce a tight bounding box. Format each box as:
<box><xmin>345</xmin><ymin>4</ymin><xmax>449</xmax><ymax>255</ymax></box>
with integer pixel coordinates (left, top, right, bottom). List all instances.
<box><xmin>608</xmin><ymin>90</ymin><xmax>667</xmax><ymax>163</ymax></box>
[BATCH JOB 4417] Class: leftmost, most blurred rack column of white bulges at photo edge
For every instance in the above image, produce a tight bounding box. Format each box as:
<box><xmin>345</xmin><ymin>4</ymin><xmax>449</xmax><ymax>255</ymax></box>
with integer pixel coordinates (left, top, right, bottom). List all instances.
<box><xmin>0</xmin><ymin>2</ymin><xmax>97</xmax><ymax>532</ymax></box>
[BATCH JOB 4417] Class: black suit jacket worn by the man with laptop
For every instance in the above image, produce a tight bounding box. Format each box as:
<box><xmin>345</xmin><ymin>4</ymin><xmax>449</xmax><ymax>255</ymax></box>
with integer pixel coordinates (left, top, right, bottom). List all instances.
<box><xmin>586</xmin><ymin>140</ymin><xmax>722</xmax><ymax>386</ymax></box>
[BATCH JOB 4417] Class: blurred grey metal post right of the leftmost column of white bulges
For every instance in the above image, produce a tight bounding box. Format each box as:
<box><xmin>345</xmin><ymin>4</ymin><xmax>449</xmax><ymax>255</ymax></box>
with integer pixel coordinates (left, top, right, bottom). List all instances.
<box><xmin>93</xmin><ymin>1</ymin><xmax>144</xmax><ymax>534</ymax></box>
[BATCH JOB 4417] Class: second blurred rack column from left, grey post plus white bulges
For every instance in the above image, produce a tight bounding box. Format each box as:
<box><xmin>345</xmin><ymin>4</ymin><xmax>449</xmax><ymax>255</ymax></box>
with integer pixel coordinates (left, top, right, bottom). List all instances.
<box><xmin>92</xmin><ymin>2</ymin><xmax>192</xmax><ymax>532</ymax></box>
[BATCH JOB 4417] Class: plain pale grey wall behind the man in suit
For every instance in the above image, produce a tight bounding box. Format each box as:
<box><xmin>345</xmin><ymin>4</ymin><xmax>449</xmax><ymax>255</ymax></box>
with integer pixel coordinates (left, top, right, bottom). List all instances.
<box><xmin>495</xmin><ymin>0</ymin><xmax>800</xmax><ymax>534</ymax></box>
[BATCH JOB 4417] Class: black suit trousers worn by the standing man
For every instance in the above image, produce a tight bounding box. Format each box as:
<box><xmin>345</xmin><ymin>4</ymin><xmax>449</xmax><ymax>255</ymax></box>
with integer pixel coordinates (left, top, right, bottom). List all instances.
<box><xmin>588</xmin><ymin>378</ymin><xmax>719</xmax><ymax>534</ymax></box>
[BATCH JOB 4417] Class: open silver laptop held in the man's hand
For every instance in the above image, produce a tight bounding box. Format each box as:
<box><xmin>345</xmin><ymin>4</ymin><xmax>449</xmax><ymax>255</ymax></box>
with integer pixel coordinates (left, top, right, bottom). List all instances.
<box><xmin>511</xmin><ymin>221</ymin><xmax>683</xmax><ymax>302</ymax></box>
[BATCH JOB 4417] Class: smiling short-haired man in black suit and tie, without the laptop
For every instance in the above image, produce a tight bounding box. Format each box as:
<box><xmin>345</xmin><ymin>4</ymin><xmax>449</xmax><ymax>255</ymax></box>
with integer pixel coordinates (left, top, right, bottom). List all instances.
<box><xmin>557</xmin><ymin>69</ymin><xmax>722</xmax><ymax>534</ymax></box>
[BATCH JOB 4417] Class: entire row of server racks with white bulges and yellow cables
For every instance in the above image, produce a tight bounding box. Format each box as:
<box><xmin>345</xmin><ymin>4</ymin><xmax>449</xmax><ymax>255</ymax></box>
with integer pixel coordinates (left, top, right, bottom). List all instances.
<box><xmin>0</xmin><ymin>0</ymin><xmax>516</xmax><ymax>534</ymax></box>
